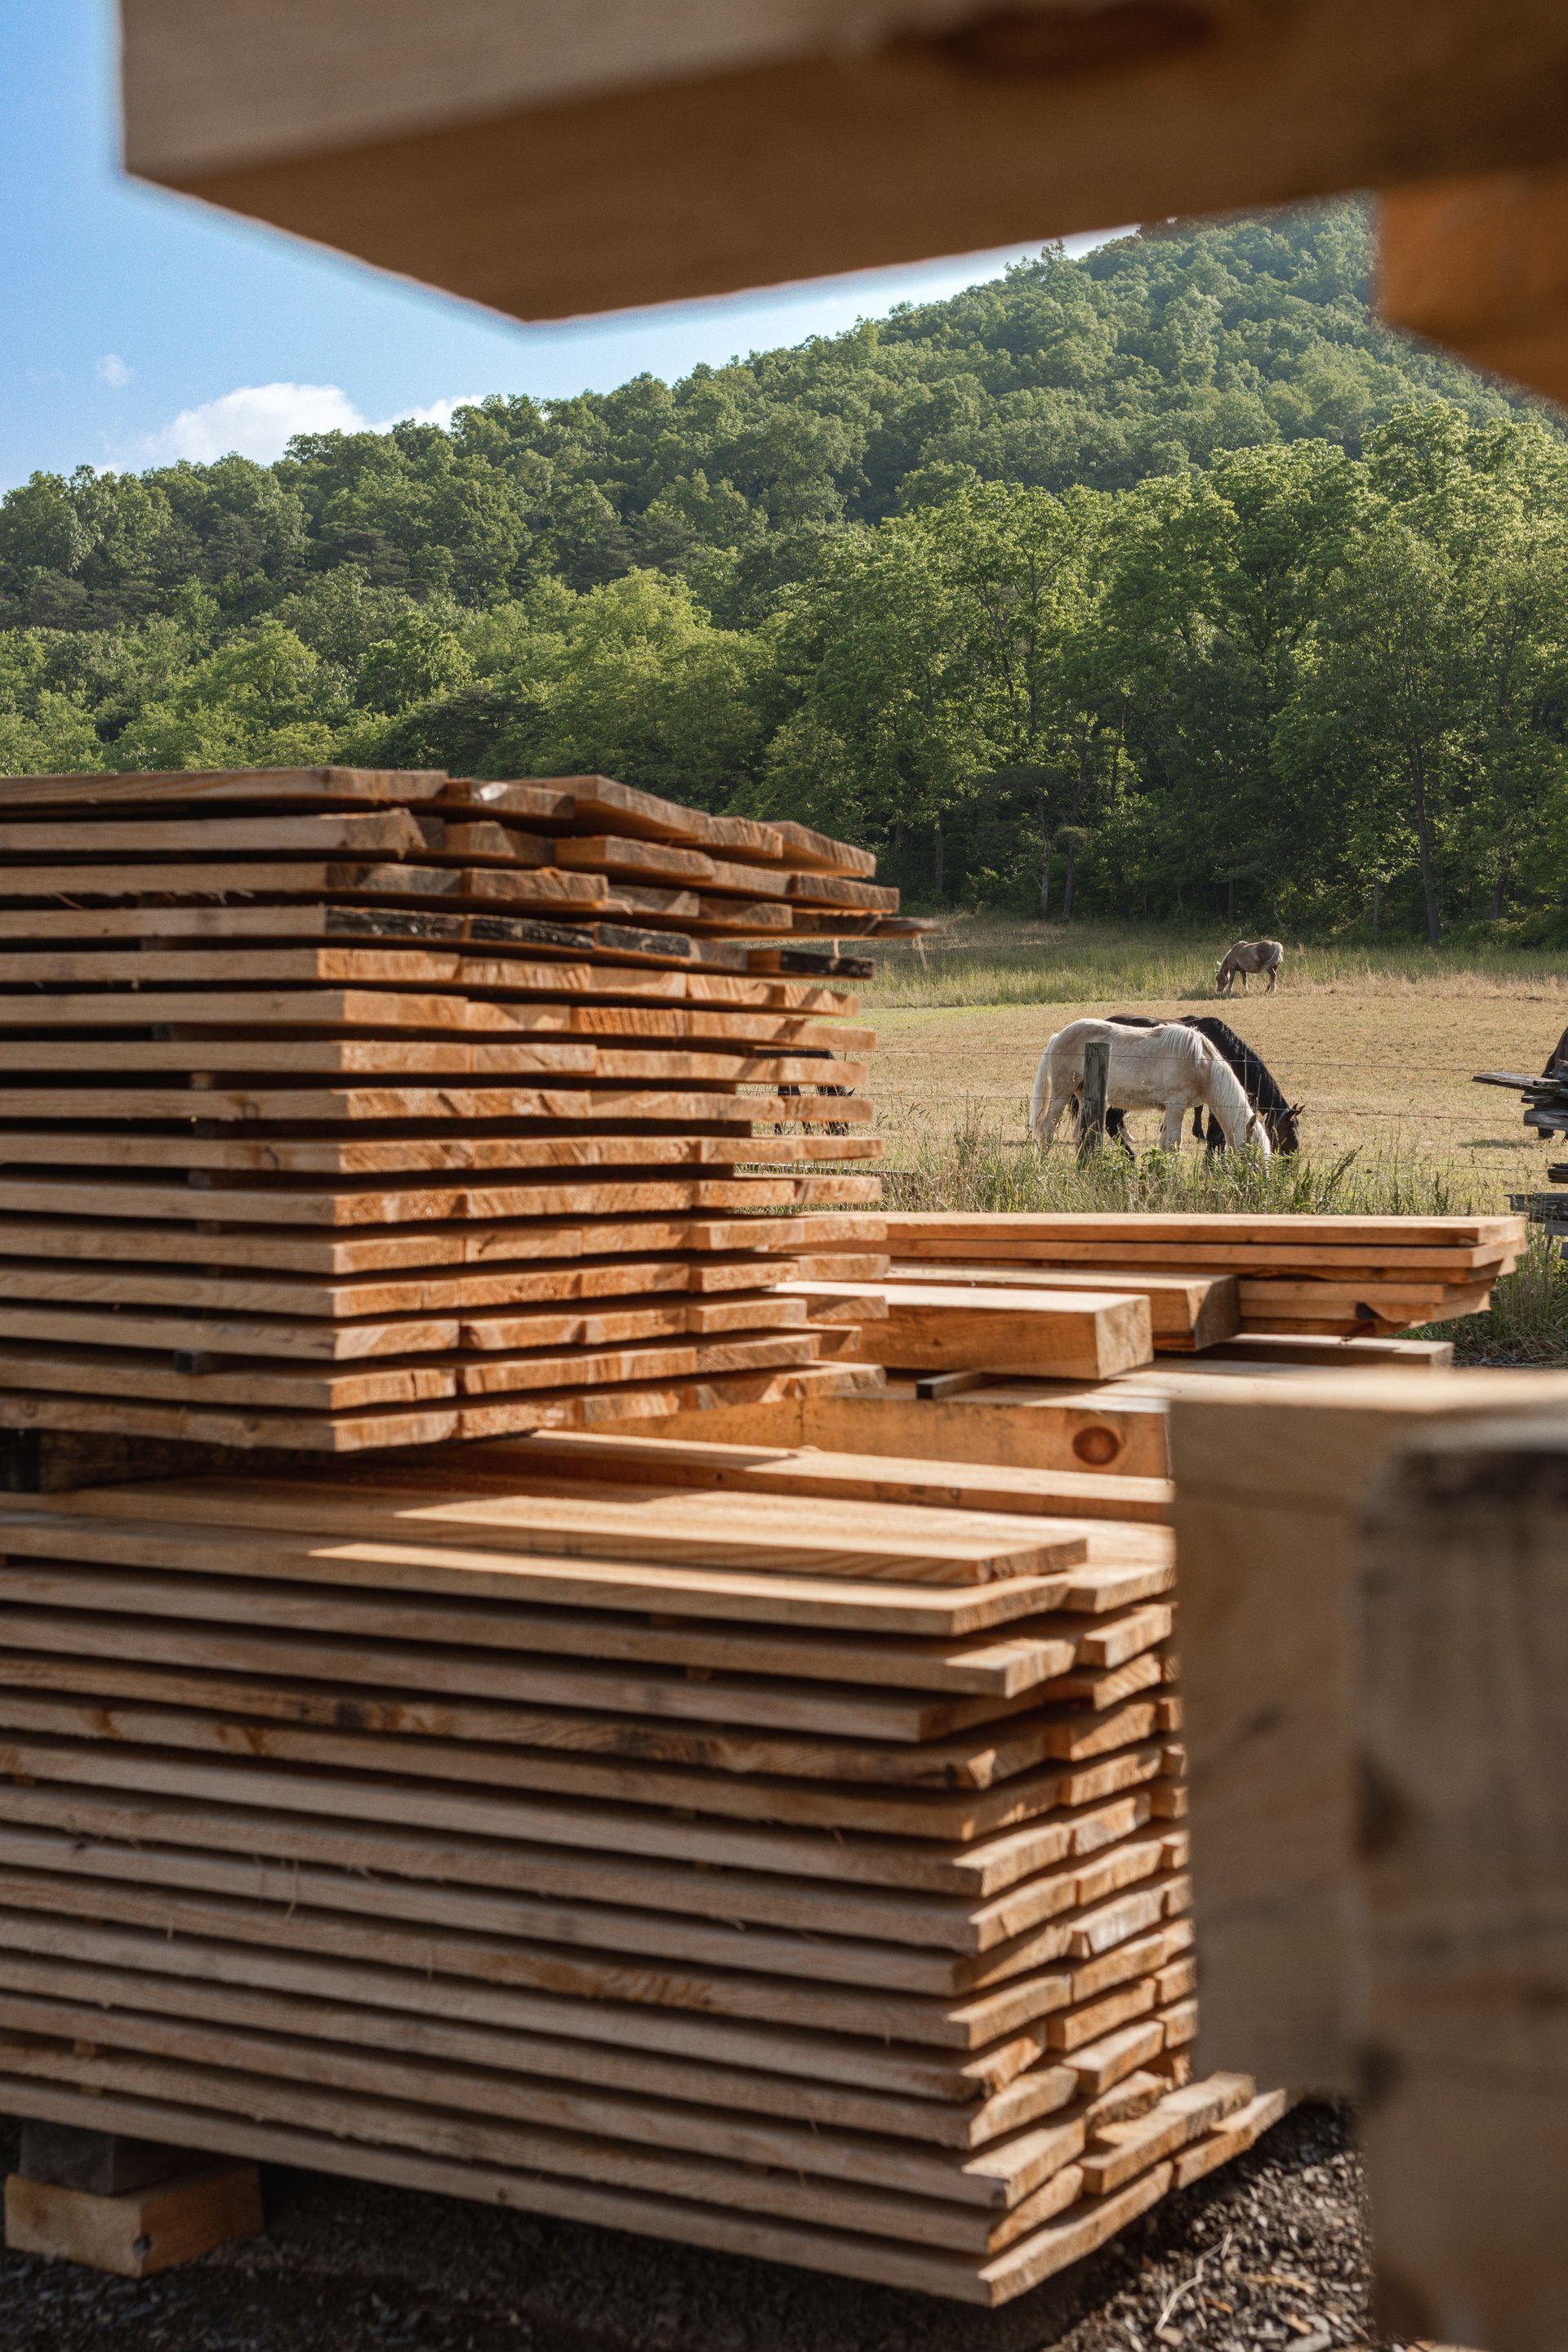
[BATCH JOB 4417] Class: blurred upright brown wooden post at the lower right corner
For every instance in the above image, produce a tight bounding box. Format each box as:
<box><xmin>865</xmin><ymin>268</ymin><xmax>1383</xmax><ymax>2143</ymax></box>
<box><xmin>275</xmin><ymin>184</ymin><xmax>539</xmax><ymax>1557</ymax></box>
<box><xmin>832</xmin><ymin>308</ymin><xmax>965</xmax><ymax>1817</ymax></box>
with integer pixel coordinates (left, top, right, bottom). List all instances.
<box><xmin>1354</xmin><ymin>1411</ymin><xmax>1568</xmax><ymax>2352</ymax></box>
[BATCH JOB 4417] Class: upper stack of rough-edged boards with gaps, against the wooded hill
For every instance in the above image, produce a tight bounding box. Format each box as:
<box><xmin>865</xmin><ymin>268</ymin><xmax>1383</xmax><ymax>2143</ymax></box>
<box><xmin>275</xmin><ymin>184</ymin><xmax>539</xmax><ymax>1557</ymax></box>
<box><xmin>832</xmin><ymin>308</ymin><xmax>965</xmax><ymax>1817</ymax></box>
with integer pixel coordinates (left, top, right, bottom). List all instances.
<box><xmin>0</xmin><ymin>769</ymin><xmax>896</xmax><ymax>1451</ymax></box>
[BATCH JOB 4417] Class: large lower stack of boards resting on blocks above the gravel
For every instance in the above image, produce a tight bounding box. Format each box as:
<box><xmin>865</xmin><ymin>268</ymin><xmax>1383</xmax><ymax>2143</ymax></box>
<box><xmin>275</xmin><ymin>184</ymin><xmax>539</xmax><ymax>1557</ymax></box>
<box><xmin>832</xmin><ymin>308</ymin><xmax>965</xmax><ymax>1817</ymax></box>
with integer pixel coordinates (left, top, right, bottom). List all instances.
<box><xmin>0</xmin><ymin>1435</ymin><xmax>1284</xmax><ymax>2305</ymax></box>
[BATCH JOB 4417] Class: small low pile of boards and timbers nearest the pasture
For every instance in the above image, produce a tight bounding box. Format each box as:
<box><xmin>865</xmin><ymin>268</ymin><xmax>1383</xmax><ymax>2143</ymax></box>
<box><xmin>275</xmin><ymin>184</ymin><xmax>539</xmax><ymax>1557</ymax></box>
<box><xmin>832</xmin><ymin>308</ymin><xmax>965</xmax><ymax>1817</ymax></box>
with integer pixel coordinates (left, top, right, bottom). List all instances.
<box><xmin>790</xmin><ymin>1211</ymin><xmax>1523</xmax><ymax>1379</ymax></box>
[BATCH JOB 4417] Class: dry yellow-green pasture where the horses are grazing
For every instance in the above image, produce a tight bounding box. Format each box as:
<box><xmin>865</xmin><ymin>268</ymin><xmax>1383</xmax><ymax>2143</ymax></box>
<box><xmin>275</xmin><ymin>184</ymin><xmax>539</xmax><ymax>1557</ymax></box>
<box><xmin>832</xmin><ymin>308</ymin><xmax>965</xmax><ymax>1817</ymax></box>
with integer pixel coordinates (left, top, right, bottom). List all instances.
<box><xmin>861</xmin><ymin>917</ymin><xmax>1568</xmax><ymax>1362</ymax></box>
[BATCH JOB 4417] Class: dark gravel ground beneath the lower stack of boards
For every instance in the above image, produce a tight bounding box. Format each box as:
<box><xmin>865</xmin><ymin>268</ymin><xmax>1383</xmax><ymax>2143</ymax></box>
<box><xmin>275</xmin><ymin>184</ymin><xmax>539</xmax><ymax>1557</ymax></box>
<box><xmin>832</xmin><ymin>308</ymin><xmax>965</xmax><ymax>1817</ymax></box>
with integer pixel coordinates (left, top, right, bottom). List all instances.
<box><xmin>0</xmin><ymin>2105</ymin><xmax>1410</xmax><ymax>2352</ymax></box>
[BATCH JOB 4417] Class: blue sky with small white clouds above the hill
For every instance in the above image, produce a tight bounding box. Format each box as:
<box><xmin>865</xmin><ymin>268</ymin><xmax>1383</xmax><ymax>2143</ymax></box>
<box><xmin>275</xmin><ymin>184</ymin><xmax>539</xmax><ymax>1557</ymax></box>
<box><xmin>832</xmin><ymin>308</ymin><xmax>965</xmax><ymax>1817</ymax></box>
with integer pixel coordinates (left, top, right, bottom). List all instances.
<box><xmin>0</xmin><ymin>0</ymin><xmax>1128</xmax><ymax>489</ymax></box>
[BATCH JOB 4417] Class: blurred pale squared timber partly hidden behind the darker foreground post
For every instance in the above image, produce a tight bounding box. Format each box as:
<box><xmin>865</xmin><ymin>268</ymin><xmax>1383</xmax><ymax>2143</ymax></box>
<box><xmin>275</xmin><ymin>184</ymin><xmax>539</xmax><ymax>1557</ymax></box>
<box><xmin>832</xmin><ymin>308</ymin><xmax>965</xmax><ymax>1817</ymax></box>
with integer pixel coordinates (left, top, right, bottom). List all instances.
<box><xmin>1171</xmin><ymin>1371</ymin><xmax>1568</xmax><ymax>2093</ymax></box>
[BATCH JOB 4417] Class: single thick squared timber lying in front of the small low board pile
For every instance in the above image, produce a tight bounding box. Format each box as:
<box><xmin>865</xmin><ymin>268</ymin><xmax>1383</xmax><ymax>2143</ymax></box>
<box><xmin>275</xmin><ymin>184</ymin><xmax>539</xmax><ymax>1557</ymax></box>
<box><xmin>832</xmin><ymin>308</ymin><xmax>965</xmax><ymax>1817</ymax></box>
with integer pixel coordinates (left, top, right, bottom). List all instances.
<box><xmin>822</xmin><ymin>1282</ymin><xmax>1154</xmax><ymax>1381</ymax></box>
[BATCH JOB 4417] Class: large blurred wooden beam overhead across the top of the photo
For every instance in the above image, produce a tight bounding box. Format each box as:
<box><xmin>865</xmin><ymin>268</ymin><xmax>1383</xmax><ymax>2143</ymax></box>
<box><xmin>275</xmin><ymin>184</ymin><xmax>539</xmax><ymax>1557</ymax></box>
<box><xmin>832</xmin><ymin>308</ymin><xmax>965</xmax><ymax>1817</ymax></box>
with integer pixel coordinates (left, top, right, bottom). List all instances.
<box><xmin>122</xmin><ymin>0</ymin><xmax>1568</xmax><ymax>318</ymax></box>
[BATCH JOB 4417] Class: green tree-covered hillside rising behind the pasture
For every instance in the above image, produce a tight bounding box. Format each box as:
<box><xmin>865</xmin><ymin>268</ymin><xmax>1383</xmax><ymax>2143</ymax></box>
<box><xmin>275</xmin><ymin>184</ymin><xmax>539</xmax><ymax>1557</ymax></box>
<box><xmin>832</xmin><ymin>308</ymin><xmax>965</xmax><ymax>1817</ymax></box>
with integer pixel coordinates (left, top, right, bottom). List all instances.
<box><xmin>0</xmin><ymin>207</ymin><xmax>1568</xmax><ymax>931</ymax></box>
